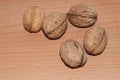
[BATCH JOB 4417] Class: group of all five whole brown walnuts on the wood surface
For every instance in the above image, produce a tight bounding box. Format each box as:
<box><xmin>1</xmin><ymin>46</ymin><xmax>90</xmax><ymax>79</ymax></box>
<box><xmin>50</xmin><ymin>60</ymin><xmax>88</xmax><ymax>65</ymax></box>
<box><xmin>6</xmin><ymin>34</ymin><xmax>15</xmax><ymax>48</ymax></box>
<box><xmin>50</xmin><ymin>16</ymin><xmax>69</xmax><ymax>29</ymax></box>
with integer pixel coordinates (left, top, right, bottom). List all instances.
<box><xmin>23</xmin><ymin>3</ymin><xmax>107</xmax><ymax>68</ymax></box>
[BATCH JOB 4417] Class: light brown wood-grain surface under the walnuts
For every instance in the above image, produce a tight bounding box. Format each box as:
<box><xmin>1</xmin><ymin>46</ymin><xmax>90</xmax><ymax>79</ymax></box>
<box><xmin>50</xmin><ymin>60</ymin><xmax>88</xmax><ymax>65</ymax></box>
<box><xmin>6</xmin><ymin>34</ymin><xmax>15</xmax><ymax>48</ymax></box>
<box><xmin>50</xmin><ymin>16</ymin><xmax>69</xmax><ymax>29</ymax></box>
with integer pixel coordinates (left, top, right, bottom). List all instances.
<box><xmin>0</xmin><ymin>0</ymin><xmax>120</xmax><ymax>80</ymax></box>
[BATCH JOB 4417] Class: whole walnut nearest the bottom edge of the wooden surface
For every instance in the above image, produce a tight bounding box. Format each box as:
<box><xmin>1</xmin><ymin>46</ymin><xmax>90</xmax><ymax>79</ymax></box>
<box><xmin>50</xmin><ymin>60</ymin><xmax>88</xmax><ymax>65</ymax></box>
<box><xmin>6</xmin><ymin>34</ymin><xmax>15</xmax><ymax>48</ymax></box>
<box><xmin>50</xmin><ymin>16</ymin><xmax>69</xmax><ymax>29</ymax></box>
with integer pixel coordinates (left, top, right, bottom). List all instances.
<box><xmin>59</xmin><ymin>39</ymin><xmax>87</xmax><ymax>68</ymax></box>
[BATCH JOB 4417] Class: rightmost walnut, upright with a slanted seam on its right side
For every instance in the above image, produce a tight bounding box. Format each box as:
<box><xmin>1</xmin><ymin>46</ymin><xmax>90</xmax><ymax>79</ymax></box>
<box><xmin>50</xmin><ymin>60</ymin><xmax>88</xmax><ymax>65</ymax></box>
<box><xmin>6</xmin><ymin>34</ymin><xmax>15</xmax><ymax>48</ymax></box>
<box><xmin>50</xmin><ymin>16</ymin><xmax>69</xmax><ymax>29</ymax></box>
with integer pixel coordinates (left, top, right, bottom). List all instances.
<box><xmin>84</xmin><ymin>26</ymin><xmax>107</xmax><ymax>55</ymax></box>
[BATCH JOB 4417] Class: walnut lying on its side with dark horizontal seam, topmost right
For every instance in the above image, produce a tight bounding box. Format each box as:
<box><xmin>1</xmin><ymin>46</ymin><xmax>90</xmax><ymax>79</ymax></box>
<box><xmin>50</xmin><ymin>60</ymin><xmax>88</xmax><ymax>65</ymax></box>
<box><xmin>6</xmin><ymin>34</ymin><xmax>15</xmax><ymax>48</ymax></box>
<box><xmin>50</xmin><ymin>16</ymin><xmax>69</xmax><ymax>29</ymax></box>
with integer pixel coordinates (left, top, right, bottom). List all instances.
<box><xmin>67</xmin><ymin>3</ymin><xmax>97</xmax><ymax>28</ymax></box>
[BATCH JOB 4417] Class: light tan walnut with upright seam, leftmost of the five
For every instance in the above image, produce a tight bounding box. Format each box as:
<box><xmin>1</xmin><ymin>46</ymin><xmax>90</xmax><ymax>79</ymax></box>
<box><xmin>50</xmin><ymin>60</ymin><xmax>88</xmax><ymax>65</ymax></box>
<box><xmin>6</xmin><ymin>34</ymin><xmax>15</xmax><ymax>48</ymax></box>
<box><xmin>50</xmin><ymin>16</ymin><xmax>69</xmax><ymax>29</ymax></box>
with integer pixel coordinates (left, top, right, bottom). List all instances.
<box><xmin>23</xmin><ymin>6</ymin><xmax>45</xmax><ymax>33</ymax></box>
